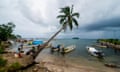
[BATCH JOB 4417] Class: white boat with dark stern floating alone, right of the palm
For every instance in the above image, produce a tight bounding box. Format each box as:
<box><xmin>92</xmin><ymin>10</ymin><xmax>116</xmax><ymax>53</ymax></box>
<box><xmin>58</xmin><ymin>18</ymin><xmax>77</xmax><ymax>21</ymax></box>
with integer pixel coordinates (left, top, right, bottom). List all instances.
<box><xmin>86</xmin><ymin>46</ymin><xmax>104</xmax><ymax>57</ymax></box>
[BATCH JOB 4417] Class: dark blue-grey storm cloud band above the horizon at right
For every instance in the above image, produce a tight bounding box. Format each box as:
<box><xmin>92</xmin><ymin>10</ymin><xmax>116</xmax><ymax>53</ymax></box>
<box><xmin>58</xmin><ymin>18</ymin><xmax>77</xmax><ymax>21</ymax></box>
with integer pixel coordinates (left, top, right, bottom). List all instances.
<box><xmin>85</xmin><ymin>17</ymin><xmax>120</xmax><ymax>31</ymax></box>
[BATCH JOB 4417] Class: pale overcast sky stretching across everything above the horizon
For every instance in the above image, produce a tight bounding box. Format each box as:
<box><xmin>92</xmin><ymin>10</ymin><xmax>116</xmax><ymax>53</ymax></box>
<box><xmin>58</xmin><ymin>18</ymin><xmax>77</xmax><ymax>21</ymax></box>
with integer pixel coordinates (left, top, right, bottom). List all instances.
<box><xmin>0</xmin><ymin>0</ymin><xmax>120</xmax><ymax>38</ymax></box>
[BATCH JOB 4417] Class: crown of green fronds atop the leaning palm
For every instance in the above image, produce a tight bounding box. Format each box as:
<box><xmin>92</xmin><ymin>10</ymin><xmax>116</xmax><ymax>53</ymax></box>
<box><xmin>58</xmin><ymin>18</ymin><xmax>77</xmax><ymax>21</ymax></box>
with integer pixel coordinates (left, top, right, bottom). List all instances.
<box><xmin>57</xmin><ymin>5</ymin><xmax>79</xmax><ymax>30</ymax></box>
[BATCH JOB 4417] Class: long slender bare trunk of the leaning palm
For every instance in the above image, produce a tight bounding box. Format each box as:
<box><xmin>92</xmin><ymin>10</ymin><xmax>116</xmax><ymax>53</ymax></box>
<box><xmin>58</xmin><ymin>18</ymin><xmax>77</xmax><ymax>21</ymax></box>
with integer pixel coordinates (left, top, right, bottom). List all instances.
<box><xmin>34</xmin><ymin>27</ymin><xmax>64</xmax><ymax>59</ymax></box>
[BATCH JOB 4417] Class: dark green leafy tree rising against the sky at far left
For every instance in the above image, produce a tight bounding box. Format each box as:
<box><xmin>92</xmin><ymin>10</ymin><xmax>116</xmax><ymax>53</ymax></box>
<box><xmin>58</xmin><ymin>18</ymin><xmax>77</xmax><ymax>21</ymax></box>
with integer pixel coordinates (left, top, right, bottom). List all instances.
<box><xmin>0</xmin><ymin>22</ymin><xmax>15</xmax><ymax>41</ymax></box>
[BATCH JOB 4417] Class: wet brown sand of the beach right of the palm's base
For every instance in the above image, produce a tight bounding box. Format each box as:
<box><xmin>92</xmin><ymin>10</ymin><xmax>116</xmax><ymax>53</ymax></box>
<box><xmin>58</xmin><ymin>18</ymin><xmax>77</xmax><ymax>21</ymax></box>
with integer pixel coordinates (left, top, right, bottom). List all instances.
<box><xmin>36</xmin><ymin>53</ymin><xmax>120</xmax><ymax>72</ymax></box>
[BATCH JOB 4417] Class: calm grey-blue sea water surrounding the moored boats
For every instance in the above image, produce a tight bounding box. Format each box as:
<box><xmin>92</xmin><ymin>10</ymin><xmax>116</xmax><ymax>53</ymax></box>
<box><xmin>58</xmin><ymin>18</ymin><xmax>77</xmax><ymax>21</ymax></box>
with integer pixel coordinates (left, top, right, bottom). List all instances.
<box><xmin>36</xmin><ymin>39</ymin><xmax>120</xmax><ymax>69</ymax></box>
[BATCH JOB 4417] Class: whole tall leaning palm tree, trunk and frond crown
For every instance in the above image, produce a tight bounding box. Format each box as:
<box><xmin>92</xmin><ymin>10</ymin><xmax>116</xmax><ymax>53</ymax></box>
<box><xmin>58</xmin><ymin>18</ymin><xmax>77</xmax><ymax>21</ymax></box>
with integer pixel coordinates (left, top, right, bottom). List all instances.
<box><xmin>34</xmin><ymin>5</ymin><xmax>79</xmax><ymax>58</ymax></box>
